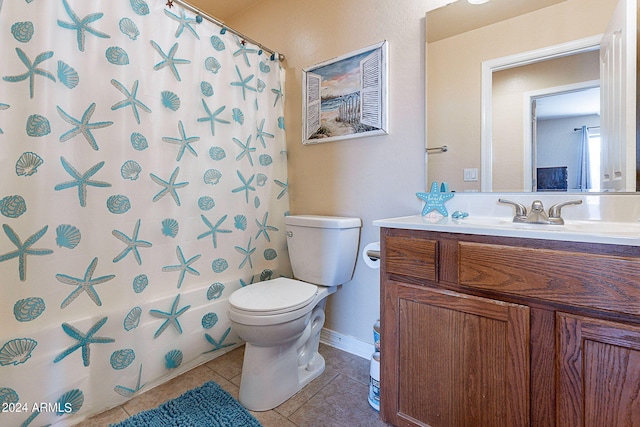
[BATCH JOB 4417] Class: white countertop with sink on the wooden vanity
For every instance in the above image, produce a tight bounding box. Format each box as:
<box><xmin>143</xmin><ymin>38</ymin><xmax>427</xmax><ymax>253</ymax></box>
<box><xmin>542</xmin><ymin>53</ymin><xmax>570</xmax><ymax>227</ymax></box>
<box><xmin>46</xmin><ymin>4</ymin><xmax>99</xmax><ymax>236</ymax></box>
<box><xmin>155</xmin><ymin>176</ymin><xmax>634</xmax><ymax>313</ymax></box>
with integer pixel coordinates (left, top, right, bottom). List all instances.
<box><xmin>374</xmin><ymin>215</ymin><xmax>640</xmax><ymax>246</ymax></box>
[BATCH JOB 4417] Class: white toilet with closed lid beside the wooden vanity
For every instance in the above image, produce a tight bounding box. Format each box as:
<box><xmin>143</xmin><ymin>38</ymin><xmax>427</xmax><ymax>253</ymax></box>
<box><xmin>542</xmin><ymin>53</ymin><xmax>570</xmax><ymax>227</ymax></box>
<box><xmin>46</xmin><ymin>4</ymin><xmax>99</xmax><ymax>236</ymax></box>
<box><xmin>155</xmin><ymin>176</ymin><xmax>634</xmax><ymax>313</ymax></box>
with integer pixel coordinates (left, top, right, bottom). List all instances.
<box><xmin>229</xmin><ymin>215</ymin><xmax>362</xmax><ymax>411</ymax></box>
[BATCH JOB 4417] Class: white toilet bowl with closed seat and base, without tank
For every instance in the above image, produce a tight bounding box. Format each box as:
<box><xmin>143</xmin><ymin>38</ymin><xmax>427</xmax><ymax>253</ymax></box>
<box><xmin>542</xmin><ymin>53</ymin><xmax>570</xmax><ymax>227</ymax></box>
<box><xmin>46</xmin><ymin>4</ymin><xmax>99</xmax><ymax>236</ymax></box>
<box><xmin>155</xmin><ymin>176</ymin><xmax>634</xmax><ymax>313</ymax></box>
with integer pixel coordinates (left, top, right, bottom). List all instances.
<box><xmin>229</xmin><ymin>278</ymin><xmax>336</xmax><ymax>411</ymax></box>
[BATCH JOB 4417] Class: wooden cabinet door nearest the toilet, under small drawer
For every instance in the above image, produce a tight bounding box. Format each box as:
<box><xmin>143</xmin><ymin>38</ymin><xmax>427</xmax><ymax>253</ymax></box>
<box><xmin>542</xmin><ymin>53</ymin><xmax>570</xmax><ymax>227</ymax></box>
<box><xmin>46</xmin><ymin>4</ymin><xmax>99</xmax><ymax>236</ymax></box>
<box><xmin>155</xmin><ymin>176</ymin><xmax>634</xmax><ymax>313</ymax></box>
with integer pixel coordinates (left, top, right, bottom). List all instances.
<box><xmin>390</xmin><ymin>285</ymin><xmax>530</xmax><ymax>427</ymax></box>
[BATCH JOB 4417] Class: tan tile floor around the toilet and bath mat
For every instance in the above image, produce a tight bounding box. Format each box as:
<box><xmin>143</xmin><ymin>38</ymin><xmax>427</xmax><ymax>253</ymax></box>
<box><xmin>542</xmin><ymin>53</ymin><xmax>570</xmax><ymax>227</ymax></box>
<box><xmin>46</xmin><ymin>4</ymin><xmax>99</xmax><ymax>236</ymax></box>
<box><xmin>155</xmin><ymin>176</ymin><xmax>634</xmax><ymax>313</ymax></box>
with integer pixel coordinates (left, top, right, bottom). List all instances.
<box><xmin>76</xmin><ymin>344</ymin><xmax>388</xmax><ymax>427</ymax></box>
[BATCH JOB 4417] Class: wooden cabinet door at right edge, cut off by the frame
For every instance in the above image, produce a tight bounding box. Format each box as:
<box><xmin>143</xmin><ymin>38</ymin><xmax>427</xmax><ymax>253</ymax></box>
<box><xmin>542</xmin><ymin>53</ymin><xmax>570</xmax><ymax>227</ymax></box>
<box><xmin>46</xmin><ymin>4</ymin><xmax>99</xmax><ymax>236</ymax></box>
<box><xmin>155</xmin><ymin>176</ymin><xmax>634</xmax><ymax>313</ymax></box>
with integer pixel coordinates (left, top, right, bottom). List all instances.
<box><xmin>556</xmin><ymin>313</ymin><xmax>640</xmax><ymax>427</ymax></box>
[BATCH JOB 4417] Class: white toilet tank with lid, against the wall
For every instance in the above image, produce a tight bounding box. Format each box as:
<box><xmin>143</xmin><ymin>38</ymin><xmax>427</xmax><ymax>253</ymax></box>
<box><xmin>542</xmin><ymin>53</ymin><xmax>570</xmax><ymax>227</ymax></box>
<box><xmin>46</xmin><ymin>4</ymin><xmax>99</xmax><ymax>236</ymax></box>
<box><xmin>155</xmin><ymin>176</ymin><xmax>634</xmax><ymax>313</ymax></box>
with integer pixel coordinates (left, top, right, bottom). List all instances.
<box><xmin>284</xmin><ymin>215</ymin><xmax>362</xmax><ymax>286</ymax></box>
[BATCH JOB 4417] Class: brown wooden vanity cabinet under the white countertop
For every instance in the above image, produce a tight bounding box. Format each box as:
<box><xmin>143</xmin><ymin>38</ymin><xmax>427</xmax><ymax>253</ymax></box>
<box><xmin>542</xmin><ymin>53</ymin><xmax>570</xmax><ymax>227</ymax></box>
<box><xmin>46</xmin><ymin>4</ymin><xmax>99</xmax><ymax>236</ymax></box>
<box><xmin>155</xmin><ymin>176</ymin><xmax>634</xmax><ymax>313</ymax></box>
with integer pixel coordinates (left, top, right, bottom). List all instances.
<box><xmin>380</xmin><ymin>228</ymin><xmax>640</xmax><ymax>427</ymax></box>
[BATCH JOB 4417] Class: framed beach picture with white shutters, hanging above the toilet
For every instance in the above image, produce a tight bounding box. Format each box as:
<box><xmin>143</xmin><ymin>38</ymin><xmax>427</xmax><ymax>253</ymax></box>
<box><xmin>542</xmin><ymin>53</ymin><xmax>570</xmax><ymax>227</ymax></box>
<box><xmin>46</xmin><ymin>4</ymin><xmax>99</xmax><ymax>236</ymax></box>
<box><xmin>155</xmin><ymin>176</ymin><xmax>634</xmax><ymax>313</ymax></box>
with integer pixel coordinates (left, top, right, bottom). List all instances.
<box><xmin>302</xmin><ymin>41</ymin><xmax>388</xmax><ymax>144</ymax></box>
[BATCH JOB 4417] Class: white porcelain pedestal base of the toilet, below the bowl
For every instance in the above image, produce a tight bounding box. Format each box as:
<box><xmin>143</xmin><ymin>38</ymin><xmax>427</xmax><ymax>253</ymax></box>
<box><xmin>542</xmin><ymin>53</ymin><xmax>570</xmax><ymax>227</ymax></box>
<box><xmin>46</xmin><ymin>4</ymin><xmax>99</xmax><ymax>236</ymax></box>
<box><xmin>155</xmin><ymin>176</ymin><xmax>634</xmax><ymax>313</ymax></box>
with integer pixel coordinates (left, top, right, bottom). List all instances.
<box><xmin>238</xmin><ymin>301</ymin><xmax>325</xmax><ymax>411</ymax></box>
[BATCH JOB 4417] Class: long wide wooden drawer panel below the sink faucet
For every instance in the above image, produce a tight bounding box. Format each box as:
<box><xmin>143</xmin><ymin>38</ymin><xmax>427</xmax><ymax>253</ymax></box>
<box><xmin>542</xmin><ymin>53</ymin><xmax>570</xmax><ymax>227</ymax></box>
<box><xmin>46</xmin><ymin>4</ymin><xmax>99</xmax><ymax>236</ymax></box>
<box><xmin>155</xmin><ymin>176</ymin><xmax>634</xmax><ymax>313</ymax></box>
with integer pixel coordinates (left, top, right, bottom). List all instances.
<box><xmin>458</xmin><ymin>242</ymin><xmax>640</xmax><ymax>315</ymax></box>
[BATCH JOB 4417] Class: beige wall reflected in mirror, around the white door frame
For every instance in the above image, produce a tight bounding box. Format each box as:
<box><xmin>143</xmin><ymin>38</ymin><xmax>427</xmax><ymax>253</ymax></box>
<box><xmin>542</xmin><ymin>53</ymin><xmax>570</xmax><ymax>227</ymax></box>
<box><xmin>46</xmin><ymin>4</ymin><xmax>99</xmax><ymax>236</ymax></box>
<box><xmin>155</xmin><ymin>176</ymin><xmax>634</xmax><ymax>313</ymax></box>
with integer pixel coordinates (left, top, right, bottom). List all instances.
<box><xmin>427</xmin><ymin>0</ymin><xmax>617</xmax><ymax>191</ymax></box>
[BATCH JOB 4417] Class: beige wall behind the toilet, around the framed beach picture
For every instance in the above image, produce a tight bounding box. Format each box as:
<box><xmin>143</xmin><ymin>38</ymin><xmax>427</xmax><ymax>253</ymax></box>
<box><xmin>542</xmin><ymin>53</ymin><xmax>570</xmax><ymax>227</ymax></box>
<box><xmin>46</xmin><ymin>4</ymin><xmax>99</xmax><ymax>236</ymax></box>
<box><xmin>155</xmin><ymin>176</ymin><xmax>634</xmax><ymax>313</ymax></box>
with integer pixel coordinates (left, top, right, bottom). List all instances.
<box><xmin>222</xmin><ymin>0</ymin><xmax>426</xmax><ymax>343</ymax></box>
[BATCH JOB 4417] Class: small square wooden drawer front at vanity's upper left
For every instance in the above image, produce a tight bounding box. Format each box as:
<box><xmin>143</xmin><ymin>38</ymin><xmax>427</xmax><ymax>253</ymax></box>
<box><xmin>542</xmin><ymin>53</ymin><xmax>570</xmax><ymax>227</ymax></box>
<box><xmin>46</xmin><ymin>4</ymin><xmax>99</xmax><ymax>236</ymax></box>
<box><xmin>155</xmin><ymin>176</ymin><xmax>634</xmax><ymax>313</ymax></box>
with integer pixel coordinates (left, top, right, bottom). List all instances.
<box><xmin>384</xmin><ymin>236</ymin><xmax>438</xmax><ymax>282</ymax></box>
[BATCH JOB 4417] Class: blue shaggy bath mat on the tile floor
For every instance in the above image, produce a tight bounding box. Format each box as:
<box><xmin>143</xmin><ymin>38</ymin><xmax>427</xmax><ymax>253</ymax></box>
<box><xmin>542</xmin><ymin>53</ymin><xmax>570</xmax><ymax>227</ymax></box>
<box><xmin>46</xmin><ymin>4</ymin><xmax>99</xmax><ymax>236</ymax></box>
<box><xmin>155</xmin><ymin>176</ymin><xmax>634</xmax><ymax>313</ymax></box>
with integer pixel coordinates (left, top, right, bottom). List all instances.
<box><xmin>111</xmin><ymin>381</ymin><xmax>262</xmax><ymax>427</ymax></box>
